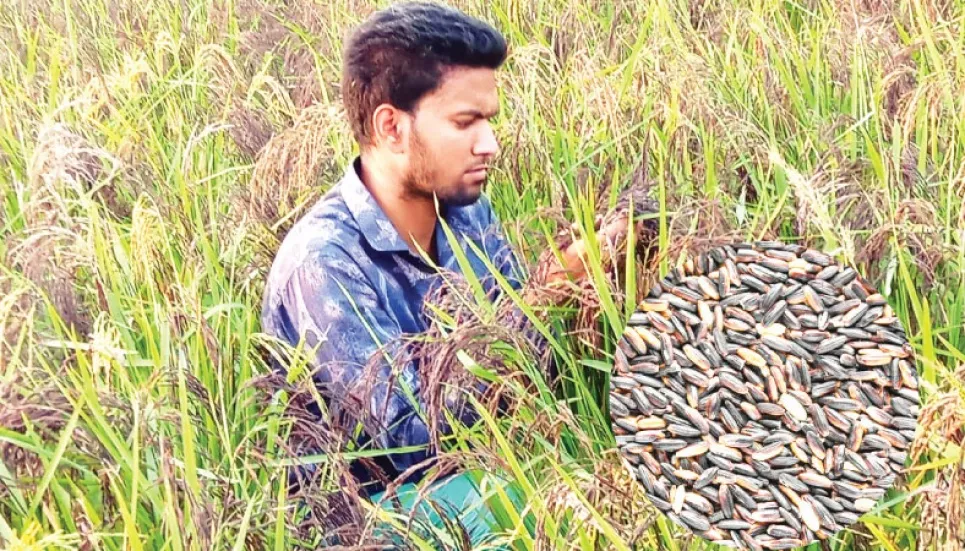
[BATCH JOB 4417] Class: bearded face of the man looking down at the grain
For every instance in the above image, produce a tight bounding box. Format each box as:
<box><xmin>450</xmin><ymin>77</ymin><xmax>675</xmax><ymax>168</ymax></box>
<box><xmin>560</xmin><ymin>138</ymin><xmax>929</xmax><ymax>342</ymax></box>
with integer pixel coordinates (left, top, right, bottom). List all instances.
<box><xmin>403</xmin><ymin>67</ymin><xmax>499</xmax><ymax>206</ymax></box>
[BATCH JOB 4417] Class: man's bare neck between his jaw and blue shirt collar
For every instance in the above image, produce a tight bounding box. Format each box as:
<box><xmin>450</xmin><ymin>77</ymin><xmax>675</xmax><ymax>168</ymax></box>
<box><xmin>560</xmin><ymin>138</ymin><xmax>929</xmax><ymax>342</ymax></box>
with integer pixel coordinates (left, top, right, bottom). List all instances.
<box><xmin>359</xmin><ymin>153</ymin><xmax>438</xmax><ymax>262</ymax></box>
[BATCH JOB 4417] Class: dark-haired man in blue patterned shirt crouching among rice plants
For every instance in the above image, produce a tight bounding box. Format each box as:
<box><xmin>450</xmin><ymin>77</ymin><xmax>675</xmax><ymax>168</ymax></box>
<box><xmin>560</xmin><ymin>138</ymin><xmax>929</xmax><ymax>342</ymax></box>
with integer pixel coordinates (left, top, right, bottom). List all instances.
<box><xmin>262</xmin><ymin>3</ymin><xmax>626</xmax><ymax>544</ymax></box>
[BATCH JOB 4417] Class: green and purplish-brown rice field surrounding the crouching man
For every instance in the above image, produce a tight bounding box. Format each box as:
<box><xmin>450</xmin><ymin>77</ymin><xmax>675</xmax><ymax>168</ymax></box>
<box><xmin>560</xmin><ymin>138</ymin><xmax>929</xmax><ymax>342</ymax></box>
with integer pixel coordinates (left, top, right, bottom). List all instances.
<box><xmin>0</xmin><ymin>0</ymin><xmax>965</xmax><ymax>551</ymax></box>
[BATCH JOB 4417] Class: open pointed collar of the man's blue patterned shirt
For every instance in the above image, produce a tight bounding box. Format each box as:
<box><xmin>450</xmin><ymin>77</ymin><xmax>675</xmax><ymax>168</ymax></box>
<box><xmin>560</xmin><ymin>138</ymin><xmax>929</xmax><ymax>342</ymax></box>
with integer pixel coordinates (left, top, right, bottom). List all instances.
<box><xmin>339</xmin><ymin>157</ymin><xmax>471</xmax><ymax>252</ymax></box>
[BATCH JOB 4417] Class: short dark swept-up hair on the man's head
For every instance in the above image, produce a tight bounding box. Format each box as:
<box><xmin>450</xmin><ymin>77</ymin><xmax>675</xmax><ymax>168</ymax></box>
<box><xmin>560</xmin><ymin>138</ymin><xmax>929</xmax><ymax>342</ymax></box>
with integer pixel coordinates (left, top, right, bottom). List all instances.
<box><xmin>342</xmin><ymin>2</ymin><xmax>506</xmax><ymax>146</ymax></box>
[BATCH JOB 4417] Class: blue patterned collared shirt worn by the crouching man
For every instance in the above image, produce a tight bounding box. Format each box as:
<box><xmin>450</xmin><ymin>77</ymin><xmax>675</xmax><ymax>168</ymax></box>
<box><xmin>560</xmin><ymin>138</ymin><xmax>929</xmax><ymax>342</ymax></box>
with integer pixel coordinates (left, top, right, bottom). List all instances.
<box><xmin>261</xmin><ymin>157</ymin><xmax>521</xmax><ymax>492</ymax></box>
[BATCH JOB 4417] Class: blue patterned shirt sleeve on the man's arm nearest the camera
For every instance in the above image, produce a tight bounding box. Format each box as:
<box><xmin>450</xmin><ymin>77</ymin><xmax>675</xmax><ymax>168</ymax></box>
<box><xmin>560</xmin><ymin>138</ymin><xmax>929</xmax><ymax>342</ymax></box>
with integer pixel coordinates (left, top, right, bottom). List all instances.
<box><xmin>281</xmin><ymin>251</ymin><xmax>429</xmax><ymax>472</ymax></box>
